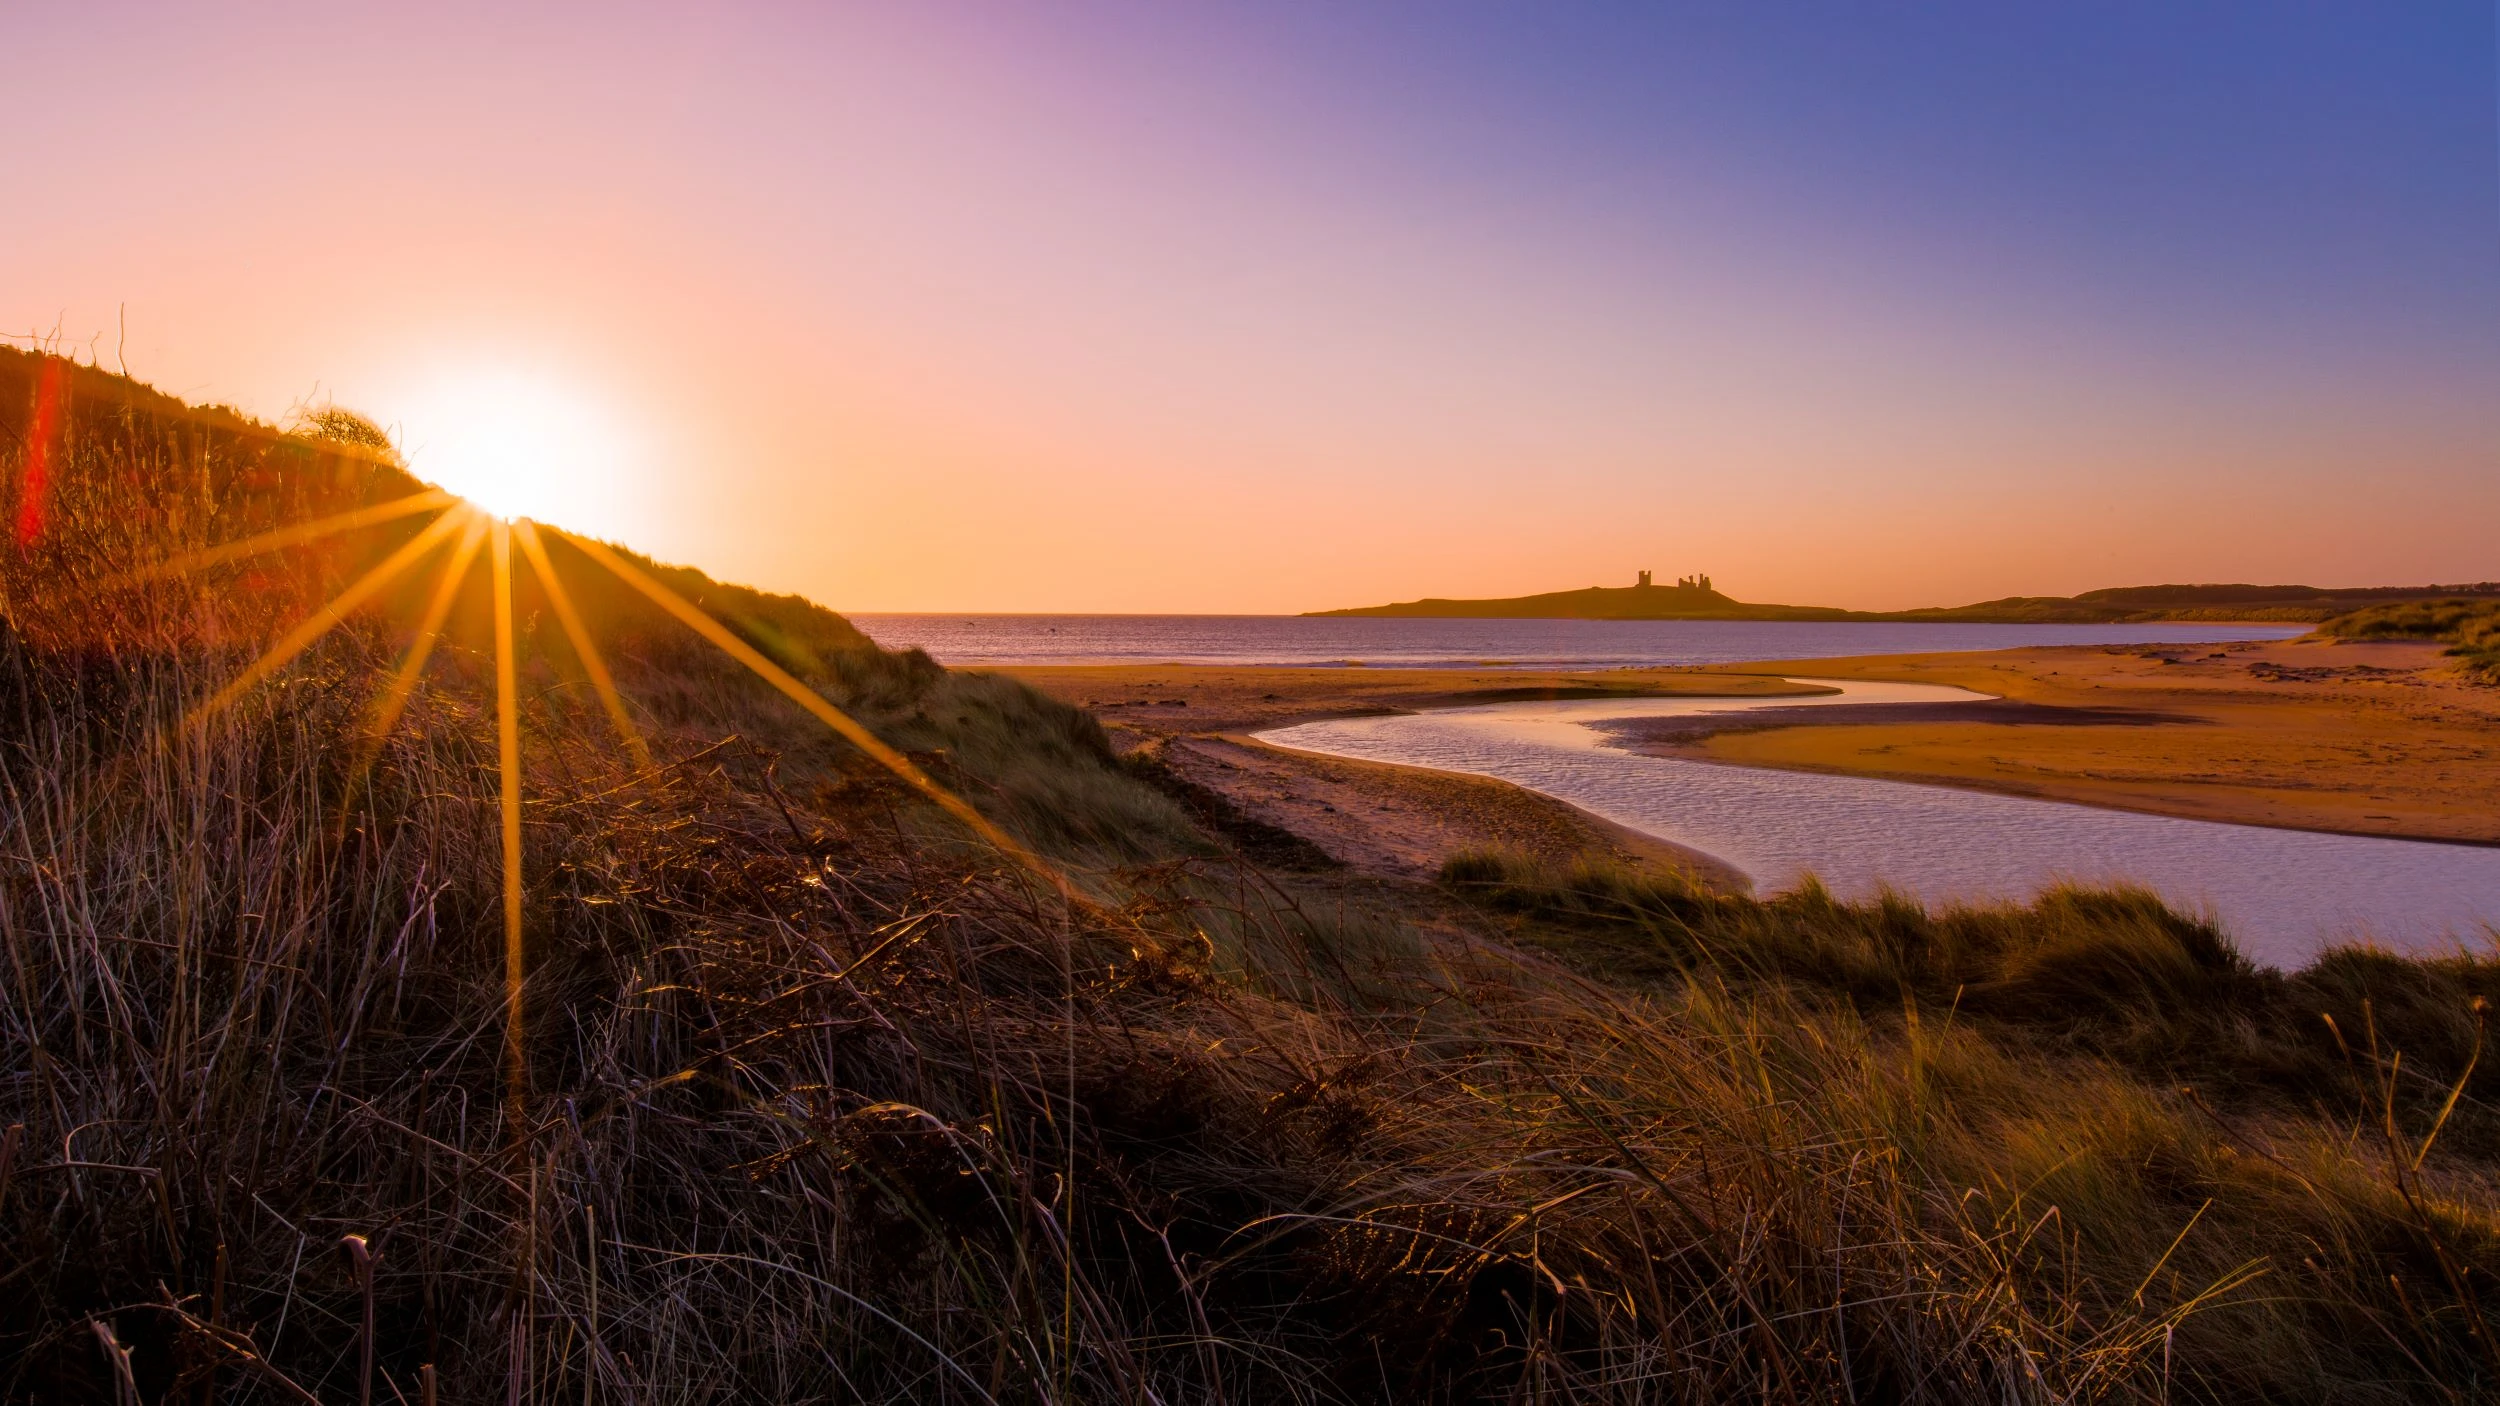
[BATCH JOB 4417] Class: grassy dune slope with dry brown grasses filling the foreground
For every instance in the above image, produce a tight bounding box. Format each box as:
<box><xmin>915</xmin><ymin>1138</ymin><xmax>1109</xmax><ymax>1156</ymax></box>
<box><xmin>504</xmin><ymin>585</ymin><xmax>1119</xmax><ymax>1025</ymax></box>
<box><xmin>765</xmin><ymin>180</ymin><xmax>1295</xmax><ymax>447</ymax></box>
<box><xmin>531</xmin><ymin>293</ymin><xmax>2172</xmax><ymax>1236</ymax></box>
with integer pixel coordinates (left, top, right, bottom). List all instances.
<box><xmin>14</xmin><ymin>342</ymin><xmax>2500</xmax><ymax>1403</ymax></box>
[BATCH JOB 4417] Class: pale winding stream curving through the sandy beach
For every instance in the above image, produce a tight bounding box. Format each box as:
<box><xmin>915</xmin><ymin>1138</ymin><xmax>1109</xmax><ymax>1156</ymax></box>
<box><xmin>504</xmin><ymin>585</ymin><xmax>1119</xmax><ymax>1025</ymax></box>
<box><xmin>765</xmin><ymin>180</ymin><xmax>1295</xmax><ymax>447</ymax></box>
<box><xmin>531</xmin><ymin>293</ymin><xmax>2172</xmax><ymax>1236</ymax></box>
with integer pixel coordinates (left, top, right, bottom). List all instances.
<box><xmin>1258</xmin><ymin>678</ymin><xmax>2500</xmax><ymax>966</ymax></box>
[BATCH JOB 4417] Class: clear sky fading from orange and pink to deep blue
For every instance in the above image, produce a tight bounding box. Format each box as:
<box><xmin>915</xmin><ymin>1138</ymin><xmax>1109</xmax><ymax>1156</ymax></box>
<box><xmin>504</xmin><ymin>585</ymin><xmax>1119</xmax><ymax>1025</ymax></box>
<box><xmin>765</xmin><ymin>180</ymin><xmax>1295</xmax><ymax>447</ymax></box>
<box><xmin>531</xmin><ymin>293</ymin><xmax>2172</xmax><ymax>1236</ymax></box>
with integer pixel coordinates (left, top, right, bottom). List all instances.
<box><xmin>0</xmin><ymin>0</ymin><xmax>2500</xmax><ymax>610</ymax></box>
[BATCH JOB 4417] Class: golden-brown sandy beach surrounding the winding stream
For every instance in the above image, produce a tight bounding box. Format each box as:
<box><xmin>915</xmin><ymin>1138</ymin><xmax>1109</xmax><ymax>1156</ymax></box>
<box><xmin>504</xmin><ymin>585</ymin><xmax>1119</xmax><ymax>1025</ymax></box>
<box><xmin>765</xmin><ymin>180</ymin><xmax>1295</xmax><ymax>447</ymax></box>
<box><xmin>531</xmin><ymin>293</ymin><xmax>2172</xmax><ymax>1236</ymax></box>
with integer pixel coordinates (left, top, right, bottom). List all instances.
<box><xmin>1008</xmin><ymin>640</ymin><xmax>2500</xmax><ymax>855</ymax></box>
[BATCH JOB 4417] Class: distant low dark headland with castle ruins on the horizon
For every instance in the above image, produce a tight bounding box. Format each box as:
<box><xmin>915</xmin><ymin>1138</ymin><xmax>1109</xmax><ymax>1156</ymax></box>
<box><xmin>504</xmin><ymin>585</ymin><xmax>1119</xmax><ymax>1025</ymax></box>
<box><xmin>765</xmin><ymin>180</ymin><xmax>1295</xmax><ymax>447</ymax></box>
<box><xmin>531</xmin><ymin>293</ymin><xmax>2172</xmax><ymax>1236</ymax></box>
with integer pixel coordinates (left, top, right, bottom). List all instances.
<box><xmin>1310</xmin><ymin>578</ymin><xmax>2500</xmax><ymax>625</ymax></box>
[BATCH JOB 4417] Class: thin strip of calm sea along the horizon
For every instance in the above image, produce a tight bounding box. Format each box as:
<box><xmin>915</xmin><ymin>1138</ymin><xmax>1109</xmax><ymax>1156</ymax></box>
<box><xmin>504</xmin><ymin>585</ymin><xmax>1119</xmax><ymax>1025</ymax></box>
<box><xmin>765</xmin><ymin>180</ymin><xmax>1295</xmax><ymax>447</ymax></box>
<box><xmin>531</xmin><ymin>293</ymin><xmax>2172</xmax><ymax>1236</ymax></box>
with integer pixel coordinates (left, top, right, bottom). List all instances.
<box><xmin>853</xmin><ymin>615</ymin><xmax>2303</xmax><ymax>668</ymax></box>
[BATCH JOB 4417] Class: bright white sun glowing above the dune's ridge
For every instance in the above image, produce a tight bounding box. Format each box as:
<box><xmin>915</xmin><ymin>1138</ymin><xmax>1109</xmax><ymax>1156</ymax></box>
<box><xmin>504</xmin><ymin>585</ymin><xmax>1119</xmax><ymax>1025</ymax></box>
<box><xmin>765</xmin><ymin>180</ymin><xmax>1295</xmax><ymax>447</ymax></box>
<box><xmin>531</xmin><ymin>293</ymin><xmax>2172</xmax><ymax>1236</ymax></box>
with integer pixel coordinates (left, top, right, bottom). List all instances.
<box><xmin>398</xmin><ymin>370</ymin><xmax>645</xmax><ymax>533</ymax></box>
